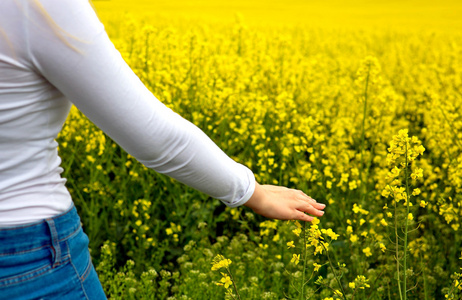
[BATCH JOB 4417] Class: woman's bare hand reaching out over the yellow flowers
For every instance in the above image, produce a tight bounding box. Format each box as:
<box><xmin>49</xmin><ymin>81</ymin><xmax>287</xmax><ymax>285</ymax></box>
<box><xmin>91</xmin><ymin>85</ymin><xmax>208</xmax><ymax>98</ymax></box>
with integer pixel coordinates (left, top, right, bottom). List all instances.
<box><xmin>244</xmin><ymin>182</ymin><xmax>326</xmax><ymax>222</ymax></box>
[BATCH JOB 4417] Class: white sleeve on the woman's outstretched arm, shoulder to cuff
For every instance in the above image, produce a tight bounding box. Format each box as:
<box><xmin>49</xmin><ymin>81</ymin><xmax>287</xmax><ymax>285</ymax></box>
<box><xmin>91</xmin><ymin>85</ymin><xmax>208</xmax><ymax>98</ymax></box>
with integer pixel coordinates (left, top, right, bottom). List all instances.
<box><xmin>23</xmin><ymin>0</ymin><xmax>255</xmax><ymax>207</ymax></box>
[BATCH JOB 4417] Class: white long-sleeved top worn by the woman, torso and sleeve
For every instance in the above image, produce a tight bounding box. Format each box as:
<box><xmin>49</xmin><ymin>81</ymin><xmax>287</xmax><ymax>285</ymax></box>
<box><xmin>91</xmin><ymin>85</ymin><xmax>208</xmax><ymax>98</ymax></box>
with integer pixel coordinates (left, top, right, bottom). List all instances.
<box><xmin>0</xmin><ymin>0</ymin><xmax>255</xmax><ymax>227</ymax></box>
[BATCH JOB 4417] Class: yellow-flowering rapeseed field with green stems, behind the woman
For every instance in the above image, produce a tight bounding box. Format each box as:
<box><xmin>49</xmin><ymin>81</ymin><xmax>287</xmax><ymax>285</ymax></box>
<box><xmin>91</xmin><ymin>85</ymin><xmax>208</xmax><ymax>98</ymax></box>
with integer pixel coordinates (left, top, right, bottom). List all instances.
<box><xmin>59</xmin><ymin>0</ymin><xmax>462</xmax><ymax>300</ymax></box>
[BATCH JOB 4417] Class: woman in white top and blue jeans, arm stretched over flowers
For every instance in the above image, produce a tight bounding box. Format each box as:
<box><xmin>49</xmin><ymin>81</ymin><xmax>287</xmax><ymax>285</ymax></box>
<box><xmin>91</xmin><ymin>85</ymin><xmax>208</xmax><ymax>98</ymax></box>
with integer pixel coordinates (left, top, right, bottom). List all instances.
<box><xmin>0</xmin><ymin>0</ymin><xmax>325</xmax><ymax>299</ymax></box>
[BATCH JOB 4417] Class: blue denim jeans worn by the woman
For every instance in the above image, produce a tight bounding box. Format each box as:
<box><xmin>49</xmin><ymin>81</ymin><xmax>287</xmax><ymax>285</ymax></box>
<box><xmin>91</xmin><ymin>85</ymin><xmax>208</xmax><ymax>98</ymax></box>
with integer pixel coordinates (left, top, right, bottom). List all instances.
<box><xmin>0</xmin><ymin>205</ymin><xmax>106</xmax><ymax>300</ymax></box>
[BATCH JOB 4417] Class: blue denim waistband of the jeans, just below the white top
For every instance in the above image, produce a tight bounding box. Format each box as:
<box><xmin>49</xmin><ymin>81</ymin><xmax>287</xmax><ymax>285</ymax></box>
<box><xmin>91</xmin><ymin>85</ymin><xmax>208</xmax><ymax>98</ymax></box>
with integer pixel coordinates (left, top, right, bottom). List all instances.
<box><xmin>0</xmin><ymin>204</ymin><xmax>81</xmax><ymax>256</ymax></box>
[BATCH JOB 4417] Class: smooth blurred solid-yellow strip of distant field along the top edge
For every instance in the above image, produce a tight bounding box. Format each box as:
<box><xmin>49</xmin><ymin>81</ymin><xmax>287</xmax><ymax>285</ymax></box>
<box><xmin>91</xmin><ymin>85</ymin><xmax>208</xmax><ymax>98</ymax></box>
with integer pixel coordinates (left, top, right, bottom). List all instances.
<box><xmin>94</xmin><ymin>0</ymin><xmax>462</xmax><ymax>31</ymax></box>
